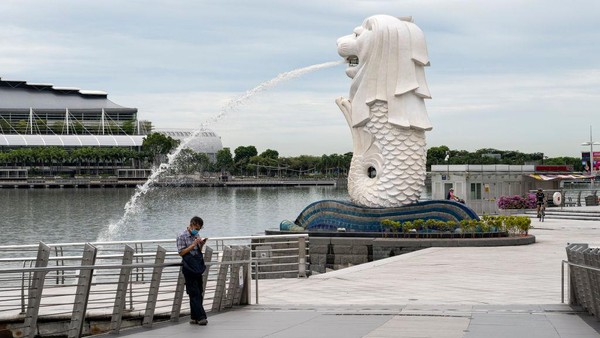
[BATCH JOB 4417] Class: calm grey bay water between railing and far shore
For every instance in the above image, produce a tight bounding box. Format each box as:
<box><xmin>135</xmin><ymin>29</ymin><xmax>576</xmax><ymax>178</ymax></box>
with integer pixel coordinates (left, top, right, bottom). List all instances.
<box><xmin>0</xmin><ymin>186</ymin><xmax>349</xmax><ymax>245</ymax></box>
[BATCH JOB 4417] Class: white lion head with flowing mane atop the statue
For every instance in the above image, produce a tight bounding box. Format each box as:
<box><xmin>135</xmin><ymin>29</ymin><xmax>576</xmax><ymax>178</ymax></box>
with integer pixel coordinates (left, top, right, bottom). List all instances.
<box><xmin>337</xmin><ymin>15</ymin><xmax>432</xmax><ymax>130</ymax></box>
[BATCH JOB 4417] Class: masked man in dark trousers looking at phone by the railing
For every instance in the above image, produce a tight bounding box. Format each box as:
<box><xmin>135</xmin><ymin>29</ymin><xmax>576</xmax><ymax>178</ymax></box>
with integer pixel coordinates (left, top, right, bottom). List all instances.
<box><xmin>177</xmin><ymin>216</ymin><xmax>208</xmax><ymax>325</ymax></box>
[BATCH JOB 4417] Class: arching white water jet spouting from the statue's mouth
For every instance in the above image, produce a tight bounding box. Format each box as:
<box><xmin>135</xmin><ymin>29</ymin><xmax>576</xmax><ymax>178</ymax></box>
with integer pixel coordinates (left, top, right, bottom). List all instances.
<box><xmin>98</xmin><ymin>61</ymin><xmax>344</xmax><ymax>241</ymax></box>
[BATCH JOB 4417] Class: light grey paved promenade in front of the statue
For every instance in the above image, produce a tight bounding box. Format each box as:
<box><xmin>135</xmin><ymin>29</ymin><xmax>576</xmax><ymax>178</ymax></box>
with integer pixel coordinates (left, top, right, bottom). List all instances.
<box><xmin>113</xmin><ymin>207</ymin><xmax>600</xmax><ymax>338</ymax></box>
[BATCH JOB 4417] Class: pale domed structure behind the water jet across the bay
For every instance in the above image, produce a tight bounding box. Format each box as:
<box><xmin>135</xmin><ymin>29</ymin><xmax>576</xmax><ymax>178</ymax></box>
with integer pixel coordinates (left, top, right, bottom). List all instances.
<box><xmin>154</xmin><ymin>129</ymin><xmax>223</xmax><ymax>162</ymax></box>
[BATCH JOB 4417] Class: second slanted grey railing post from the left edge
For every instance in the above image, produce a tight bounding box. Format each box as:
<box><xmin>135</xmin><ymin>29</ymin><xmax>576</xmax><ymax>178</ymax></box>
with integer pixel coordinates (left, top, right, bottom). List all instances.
<box><xmin>68</xmin><ymin>243</ymin><xmax>98</xmax><ymax>338</ymax></box>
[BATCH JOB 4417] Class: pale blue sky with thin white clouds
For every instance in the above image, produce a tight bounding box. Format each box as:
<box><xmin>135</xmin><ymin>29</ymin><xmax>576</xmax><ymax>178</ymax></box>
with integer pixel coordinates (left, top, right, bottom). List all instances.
<box><xmin>0</xmin><ymin>0</ymin><xmax>600</xmax><ymax>157</ymax></box>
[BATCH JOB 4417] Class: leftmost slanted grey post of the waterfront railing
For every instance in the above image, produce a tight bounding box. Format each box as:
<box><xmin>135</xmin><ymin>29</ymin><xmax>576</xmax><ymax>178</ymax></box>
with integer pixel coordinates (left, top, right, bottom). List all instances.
<box><xmin>23</xmin><ymin>242</ymin><xmax>50</xmax><ymax>338</ymax></box>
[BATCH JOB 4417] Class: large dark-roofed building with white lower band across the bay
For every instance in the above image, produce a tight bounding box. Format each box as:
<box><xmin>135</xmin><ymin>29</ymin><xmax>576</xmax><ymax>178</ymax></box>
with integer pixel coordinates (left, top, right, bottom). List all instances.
<box><xmin>0</xmin><ymin>78</ymin><xmax>149</xmax><ymax>149</ymax></box>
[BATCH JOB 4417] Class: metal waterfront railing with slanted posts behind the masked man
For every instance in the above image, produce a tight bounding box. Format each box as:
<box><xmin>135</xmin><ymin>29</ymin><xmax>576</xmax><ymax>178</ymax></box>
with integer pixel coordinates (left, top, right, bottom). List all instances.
<box><xmin>0</xmin><ymin>234</ymin><xmax>308</xmax><ymax>337</ymax></box>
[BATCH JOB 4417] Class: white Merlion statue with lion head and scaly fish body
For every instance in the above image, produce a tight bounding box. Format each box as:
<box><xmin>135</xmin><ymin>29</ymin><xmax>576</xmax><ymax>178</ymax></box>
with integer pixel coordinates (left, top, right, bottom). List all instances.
<box><xmin>336</xmin><ymin>15</ymin><xmax>432</xmax><ymax>207</ymax></box>
